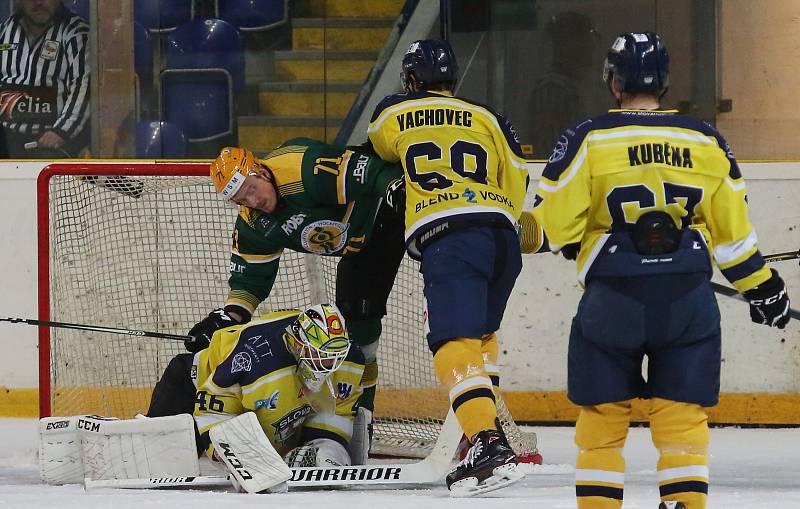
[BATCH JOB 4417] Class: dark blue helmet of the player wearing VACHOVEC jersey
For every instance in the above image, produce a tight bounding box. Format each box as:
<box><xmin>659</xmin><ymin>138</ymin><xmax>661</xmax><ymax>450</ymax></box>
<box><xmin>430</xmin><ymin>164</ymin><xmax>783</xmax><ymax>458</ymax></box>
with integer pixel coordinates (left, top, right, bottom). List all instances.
<box><xmin>400</xmin><ymin>39</ymin><xmax>458</xmax><ymax>90</ymax></box>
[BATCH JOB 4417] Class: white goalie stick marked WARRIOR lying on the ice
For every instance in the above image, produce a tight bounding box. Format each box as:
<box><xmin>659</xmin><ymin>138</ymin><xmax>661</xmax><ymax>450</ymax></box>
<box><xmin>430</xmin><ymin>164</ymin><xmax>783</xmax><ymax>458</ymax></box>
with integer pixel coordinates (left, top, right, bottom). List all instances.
<box><xmin>84</xmin><ymin>410</ymin><xmax>462</xmax><ymax>489</ymax></box>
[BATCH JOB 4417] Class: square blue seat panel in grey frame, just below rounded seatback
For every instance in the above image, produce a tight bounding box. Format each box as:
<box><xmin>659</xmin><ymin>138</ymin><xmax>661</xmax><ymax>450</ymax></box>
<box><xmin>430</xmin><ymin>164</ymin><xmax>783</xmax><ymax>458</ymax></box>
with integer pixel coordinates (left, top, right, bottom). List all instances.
<box><xmin>161</xmin><ymin>69</ymin><xmax>234</xmax><ymax>142</ymax></box>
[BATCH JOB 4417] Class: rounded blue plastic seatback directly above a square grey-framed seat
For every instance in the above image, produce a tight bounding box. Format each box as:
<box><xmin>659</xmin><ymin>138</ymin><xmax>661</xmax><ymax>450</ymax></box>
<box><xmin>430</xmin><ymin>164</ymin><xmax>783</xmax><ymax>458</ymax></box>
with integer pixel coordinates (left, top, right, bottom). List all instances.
<box><xmin>166</xmin><ymin>18</ymin><xmax>244</xmax><ymax>91</ymax></box>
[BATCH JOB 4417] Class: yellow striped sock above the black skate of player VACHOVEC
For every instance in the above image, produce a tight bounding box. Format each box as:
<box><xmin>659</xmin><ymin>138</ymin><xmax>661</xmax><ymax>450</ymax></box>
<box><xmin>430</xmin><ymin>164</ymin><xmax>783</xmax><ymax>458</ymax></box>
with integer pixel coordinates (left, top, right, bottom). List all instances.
<box><xmin>433</xmin><ymin>338</ymin><xmax>497</xmax><ymax>438</ymax></box>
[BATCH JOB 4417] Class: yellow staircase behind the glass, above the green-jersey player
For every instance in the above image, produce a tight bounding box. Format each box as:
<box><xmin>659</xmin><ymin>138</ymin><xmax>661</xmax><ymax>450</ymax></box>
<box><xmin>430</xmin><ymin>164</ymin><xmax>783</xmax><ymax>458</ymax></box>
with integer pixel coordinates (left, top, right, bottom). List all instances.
<box><xmin>239</xmin><ymin>0</ymin><xmax>404</xmax><ymax>154</ymax></box>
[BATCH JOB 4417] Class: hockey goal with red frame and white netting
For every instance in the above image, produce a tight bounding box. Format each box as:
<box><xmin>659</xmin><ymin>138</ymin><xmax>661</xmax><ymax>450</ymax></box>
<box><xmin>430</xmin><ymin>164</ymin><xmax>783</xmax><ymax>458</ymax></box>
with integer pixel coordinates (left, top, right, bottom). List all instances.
<box><xmin>38</xmin><ymin>162</ymin><xmax>536</xmax><ymax>457</ymax></box>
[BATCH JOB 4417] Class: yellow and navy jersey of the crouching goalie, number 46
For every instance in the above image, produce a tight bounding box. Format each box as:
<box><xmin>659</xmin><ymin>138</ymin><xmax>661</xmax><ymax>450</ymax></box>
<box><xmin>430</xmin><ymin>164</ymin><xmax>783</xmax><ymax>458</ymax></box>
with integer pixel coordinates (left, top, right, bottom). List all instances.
<box><xmin>192</xmin><ymin>310</ymin><xmax>364</xmax><ymax>455</ymax></box>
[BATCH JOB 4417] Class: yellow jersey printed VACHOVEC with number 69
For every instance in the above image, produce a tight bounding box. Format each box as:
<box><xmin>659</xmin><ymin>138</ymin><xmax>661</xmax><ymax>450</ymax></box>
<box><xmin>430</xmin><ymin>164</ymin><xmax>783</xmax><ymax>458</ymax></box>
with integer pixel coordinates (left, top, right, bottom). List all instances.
<box><xmin>367</xmin><ymin>91</ymin><xmax>528</xmax><ymax>259</ymax></box>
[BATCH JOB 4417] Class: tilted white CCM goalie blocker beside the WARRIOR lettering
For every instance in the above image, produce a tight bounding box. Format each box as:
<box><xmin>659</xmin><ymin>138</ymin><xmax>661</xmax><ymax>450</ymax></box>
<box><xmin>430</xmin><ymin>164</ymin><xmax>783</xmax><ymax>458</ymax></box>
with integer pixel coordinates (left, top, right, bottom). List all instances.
<box><xmin>208</xmin><ymin>412</ymin><xmax>292</xmax><ymax>493</ymax></box>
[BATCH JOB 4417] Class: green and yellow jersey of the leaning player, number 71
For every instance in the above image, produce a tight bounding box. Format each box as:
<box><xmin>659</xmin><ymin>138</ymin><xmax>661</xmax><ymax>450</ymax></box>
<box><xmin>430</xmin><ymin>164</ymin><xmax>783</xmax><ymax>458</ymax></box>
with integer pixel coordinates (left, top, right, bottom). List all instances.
<box><xmin>225</xmin><ymin>138</ymin><xmax>403</xmax><ymax>313</ymax></box>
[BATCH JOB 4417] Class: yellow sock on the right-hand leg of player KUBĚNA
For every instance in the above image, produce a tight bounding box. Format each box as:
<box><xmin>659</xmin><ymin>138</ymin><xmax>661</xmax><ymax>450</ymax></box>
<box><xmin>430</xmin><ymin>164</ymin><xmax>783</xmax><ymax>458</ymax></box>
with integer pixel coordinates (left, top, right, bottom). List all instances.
<box><xmin>650</xmin><ymin>398</ymin><xmax>708</xmax><ymax>509</ymax></box>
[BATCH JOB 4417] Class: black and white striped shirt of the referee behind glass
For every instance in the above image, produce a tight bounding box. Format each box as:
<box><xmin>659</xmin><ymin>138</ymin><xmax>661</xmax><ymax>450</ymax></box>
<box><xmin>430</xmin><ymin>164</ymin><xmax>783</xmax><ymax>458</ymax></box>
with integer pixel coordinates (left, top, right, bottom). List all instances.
<box><xmin>0</xmin><ymin>6</ymin><xmax>90</xmax><ymax>140</ymax></box>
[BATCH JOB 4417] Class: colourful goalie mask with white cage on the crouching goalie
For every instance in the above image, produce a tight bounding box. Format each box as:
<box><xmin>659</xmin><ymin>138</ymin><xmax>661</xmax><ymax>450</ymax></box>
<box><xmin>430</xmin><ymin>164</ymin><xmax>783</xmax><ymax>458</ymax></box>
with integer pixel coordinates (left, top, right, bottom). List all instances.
<box><xmin>283</xmin><ymin>304</ymin><xmax>350</xmax><ymax>394</ymax></box>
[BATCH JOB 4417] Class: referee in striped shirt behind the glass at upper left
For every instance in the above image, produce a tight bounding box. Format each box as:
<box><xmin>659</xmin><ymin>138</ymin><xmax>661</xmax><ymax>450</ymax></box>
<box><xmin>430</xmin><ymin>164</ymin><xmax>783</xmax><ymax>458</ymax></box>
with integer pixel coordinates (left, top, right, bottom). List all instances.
<box><xmin>0</xmin><ymin>0</ymin><xmax>89</xmax><ymax>159</ymax></box>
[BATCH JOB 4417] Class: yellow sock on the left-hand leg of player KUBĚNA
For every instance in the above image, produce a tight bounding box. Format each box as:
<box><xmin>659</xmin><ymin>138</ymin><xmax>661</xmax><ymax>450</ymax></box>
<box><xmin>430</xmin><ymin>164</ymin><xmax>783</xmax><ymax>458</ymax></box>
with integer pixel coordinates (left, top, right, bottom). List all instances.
<box><xmin>575</xmin><ymin>401</ymin><xmax>631</xmax><ymax>509</ymax></box>
